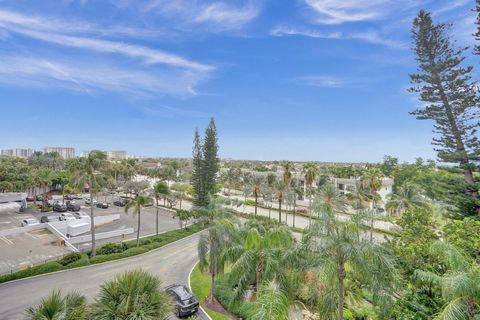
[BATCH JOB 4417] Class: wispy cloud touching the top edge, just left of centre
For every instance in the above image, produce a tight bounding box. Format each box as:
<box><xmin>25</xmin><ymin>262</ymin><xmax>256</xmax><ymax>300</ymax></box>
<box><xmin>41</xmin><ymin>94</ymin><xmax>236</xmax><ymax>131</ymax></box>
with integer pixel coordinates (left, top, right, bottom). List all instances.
<box><xmin>144</xmin><ymin>0</ymin><xmax>260</xmax><ymax>32</ymax></box>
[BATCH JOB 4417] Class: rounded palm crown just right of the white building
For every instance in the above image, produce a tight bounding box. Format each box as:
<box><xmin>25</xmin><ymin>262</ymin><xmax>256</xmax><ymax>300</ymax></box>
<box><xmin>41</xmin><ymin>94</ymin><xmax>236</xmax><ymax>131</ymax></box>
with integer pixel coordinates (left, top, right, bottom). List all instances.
<box><xmin>386</xmin><ymin>183</ymin><xmax>428</xmax><ymax>214</ymax></box>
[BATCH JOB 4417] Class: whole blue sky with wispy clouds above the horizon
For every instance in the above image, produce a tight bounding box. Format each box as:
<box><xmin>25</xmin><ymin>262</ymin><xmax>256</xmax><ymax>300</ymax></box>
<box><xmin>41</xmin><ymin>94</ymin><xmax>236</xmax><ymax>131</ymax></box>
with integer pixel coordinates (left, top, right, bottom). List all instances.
<box><xmin>0</xmin><ymin>0</ymin><xmax>478</xmax><ymax>162</ymax></box>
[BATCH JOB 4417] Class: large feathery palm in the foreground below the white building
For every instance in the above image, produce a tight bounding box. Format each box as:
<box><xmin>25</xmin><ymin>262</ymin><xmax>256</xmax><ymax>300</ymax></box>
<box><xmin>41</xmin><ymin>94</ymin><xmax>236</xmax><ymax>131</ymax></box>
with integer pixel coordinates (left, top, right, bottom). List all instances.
<box><xmin>303</xmin><ymin>204</ymin><xmax>398</xmax><ymax>320</ymax></box>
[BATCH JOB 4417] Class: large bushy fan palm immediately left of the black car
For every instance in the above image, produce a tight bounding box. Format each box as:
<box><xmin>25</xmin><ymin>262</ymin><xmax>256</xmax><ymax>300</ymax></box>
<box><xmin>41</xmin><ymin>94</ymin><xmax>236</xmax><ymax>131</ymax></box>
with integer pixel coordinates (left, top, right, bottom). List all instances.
<box><xmin>92</xmin><ymin>270</ymin><xmax>172</xmax><ymax>320</ymax></box>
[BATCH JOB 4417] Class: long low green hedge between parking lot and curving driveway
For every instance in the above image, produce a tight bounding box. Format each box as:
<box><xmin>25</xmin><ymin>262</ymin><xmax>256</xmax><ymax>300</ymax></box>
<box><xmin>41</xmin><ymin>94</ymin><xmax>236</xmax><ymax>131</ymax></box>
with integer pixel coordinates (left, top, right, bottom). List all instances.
<box><xmin>0</xmin><ymin>223</ymin><xmax>206</xmax><ymax>283</ymax></box>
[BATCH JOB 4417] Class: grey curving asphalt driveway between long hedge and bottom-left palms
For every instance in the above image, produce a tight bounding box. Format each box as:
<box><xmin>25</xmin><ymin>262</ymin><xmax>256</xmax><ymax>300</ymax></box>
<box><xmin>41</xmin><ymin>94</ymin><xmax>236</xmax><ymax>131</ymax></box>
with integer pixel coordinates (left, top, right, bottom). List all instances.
<box><xmin>0</xmin><ymin>234</ymin><xmax>199</xmax><ymax>320</ymax></box>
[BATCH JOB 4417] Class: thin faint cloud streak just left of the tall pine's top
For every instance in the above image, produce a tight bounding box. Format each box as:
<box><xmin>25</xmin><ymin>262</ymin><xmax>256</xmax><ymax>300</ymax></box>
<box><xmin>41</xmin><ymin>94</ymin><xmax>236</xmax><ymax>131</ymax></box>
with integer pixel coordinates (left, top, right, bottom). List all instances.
<box><xmin>270</xmin><ymin>26</ymin><xmax>407</xmax><ymax>49</ymax></box>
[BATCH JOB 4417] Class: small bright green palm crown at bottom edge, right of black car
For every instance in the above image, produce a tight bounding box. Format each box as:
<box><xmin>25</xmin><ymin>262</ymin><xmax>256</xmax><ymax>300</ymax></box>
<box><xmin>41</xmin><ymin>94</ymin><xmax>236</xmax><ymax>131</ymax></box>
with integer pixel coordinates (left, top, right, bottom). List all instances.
<box><xmin>252</xmin><ymin>281</ymin><xmax>289</xmax><ymax>320</ymax></box>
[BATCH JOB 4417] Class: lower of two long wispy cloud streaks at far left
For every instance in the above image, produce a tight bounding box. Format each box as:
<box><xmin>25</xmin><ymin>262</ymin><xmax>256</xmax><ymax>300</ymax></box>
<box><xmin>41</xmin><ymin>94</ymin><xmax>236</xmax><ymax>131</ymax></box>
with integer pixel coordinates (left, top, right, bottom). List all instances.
<box><xmin>0</xmin><ymin>56</ymin><xmax>201</xmax><ymax>96</ymax></box>
